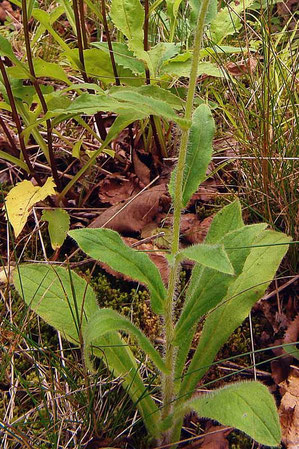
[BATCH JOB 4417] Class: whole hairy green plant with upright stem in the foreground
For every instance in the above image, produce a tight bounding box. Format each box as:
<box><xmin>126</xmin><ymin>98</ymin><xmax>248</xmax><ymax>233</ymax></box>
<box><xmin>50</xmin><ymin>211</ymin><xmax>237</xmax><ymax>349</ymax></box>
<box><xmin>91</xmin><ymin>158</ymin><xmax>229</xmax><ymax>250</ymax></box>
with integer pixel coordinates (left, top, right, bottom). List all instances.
<box><xmin>14</xmin><ymin>0</ymin><xmax>290</xmax><ymax>448</ymax></box>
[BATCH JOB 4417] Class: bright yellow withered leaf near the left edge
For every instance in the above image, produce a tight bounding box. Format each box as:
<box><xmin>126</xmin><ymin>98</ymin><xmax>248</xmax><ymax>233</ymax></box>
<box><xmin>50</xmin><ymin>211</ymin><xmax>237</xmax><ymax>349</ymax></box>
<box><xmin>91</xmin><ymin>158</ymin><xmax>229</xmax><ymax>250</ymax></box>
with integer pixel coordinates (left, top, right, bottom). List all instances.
<box><xmin>5</xmin><ymin>177</ymin><xmax>56</xmax><ymax>237</ymax></box>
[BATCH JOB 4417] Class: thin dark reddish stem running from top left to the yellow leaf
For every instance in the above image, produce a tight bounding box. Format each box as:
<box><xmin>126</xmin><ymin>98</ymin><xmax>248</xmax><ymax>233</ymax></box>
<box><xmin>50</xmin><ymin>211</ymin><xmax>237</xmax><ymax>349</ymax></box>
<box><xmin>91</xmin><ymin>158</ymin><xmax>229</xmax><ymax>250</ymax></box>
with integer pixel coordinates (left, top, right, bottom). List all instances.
<box><xmin>22</xmin><ymin>0</ymin><xmax>60</xmax><ymax>191</ymax></box>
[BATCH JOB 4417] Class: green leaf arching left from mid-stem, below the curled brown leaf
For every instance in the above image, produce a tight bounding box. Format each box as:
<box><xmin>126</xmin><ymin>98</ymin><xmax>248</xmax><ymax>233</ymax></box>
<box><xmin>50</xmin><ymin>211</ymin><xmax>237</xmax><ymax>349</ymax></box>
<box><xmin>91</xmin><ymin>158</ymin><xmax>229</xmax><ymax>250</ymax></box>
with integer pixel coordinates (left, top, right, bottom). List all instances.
<box><xmin>69</xmin><ymin>229</ymin><xmax>166</xmax><ymax>314</ymax></box>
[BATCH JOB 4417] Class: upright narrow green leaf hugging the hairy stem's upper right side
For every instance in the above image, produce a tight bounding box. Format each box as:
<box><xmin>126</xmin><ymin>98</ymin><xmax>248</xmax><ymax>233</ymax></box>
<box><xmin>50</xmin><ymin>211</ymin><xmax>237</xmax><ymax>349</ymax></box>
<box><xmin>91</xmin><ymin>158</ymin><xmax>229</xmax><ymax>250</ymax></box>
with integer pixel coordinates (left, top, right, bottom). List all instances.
<box><xmin>169</xmin><ymin>104</ymin><xmax>215</xmax><ymax>207</ymax></box>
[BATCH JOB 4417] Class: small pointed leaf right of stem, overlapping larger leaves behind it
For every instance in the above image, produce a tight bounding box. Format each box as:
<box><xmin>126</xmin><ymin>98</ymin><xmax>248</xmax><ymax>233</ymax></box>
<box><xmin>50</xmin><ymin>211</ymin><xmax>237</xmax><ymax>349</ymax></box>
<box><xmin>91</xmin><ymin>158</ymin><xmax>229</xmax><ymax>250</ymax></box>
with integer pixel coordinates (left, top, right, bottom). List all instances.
<box><xmin>179</xmin><ymin>243</ymin><xmax>234</xmax><ymax>274</ymax></box>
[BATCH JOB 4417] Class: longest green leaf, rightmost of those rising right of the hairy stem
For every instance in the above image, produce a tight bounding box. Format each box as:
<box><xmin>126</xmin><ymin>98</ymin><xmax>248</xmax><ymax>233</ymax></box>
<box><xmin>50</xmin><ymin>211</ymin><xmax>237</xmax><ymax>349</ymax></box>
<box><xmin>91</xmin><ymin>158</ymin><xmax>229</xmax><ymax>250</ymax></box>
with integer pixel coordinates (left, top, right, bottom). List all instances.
<box><xmin>180</xmin><ymin>231</ymin><xmax>291</xmax><ymax>395</ymax></box>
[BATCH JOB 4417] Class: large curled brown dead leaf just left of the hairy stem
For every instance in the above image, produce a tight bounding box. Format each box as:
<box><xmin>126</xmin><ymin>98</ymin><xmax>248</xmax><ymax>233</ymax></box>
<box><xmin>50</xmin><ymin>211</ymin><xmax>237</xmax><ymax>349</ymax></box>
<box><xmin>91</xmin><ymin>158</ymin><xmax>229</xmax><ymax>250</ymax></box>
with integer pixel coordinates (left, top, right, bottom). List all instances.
<box><xmin>89</xmin><ymin>184</ymin><xmax>166</xmax><ymax>234</ymax></box>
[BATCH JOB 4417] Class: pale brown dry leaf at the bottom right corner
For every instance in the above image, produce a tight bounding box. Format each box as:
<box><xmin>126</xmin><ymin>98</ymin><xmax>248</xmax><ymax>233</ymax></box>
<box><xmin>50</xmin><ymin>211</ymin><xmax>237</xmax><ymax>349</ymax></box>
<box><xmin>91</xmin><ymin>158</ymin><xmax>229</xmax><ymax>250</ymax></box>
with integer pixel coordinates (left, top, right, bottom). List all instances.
<box><xmin>279</xmin><ymin>368</ymin><xmax>299</xmax><ymax>449</ymax></box>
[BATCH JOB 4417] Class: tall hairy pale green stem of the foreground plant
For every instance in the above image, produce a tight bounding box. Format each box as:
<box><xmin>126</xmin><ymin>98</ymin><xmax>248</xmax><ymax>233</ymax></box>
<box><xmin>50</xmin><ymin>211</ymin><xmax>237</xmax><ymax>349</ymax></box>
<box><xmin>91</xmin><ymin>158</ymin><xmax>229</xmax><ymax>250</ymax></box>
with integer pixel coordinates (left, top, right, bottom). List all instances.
<box><xmin>162</xmin><ymin>0</ymin><xmax>210</xmax><ymax>442</ymax></box>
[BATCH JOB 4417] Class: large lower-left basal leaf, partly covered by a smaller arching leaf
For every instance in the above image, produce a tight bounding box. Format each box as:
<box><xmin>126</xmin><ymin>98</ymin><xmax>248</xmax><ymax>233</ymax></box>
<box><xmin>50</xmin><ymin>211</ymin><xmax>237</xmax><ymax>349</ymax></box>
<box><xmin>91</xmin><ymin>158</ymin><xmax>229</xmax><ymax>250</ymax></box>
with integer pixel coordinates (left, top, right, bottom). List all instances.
<box><xmin>13</xmin><ymin>264</ymin><xmax>159</xmax><ymax>435</ymax></box>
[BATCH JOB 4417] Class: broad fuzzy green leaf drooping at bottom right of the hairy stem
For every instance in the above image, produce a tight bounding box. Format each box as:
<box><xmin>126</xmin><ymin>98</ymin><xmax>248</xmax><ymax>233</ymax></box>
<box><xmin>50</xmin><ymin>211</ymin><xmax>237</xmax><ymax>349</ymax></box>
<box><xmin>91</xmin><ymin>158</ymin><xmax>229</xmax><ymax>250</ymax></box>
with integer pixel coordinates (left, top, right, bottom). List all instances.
<box><xmin>187</xmin><ymin>382</ymin><xmax>281</xmax><ymax>446</ymax></box>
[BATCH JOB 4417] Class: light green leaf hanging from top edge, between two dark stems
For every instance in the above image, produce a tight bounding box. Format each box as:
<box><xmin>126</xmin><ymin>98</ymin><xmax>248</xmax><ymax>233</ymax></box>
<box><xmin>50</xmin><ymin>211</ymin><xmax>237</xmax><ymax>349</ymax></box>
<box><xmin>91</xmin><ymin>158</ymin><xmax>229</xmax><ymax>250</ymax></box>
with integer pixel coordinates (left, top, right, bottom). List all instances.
<box><xmin>110</xmin><ymin>0</ymin><xmax>153</xmax><ymax>73</ymax></box>
